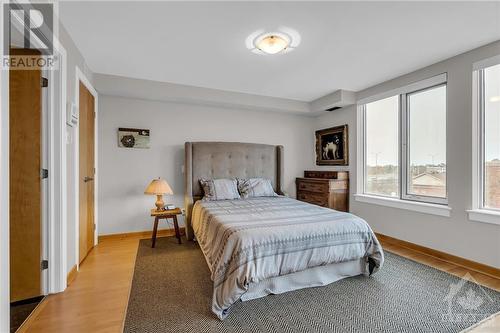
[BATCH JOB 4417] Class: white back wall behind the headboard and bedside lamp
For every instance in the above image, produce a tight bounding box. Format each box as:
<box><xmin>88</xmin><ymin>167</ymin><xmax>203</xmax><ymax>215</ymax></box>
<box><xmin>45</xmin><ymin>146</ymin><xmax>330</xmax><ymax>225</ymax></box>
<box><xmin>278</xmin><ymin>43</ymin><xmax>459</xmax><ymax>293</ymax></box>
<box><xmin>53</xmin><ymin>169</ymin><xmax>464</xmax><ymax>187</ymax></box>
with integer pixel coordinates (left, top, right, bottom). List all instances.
<box><xmin>98</xmin><ymin>95</ymin><xmax>314</xmax><ymax>234</ymax></box>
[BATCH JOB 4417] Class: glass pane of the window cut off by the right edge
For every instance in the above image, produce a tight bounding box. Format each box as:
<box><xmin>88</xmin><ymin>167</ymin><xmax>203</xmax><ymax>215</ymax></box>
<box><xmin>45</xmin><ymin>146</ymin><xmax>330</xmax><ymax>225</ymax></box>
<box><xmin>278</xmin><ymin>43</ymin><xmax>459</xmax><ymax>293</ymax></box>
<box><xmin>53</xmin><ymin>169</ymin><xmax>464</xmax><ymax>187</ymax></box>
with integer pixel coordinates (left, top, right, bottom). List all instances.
<box><xmin>484</xmin><ymin>65</ymin><xmax>500</xmax><ymax>209</ymax></box>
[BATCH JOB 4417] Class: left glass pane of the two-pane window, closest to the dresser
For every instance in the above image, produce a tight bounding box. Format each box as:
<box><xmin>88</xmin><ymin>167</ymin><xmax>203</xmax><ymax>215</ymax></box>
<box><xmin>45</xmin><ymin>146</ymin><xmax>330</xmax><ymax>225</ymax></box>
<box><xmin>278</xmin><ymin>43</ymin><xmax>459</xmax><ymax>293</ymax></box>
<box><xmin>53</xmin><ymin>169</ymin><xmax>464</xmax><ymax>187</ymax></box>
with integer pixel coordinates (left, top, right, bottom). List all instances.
<box><xmin>365</xmin><ymin>96</ymin><xmax>399</xmax><ymax>197</ymax></box>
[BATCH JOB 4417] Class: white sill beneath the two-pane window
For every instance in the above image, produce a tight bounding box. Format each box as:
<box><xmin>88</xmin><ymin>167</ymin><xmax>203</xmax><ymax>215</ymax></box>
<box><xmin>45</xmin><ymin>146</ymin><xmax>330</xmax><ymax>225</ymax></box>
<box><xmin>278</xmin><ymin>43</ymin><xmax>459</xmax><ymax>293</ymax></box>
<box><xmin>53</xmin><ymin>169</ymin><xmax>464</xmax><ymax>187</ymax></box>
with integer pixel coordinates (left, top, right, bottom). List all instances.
<box><xmin>354</xmin><ymin>194</ymin><xmax>451</xmax><ymax>217</ymax></box>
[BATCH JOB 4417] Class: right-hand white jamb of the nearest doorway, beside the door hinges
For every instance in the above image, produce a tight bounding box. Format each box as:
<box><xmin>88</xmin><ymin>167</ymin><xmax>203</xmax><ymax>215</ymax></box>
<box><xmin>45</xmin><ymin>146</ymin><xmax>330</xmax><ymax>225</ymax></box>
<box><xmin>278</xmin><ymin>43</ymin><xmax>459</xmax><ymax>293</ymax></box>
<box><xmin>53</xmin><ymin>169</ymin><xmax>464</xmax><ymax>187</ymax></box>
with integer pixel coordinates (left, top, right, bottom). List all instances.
<box><xmin>9</xmin><ymin>44</ymin><xmax>67</xmax><ymax>295</ymax></box>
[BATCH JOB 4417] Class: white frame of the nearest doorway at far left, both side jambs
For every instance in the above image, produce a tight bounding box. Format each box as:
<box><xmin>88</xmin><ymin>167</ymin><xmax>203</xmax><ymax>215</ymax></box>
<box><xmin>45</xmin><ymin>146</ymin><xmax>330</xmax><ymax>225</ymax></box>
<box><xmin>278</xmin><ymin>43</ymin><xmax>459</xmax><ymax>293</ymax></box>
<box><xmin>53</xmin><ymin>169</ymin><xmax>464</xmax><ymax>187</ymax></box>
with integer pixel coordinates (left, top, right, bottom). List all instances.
<box><xmin>0</xmin><ymin>29</ymin><xmax>67</xmax><ymax>332</ymax></box>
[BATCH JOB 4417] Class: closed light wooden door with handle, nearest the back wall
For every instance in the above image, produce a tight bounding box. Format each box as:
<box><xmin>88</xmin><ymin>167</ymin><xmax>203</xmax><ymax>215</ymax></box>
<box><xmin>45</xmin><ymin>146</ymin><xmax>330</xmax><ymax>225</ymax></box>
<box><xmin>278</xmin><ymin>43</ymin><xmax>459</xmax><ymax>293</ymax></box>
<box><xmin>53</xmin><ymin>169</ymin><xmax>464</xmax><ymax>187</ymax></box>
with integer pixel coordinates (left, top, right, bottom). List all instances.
<box><xmin>79</xmin><ymin>82</ymin><xmax>95</xmax><ymax>263</ymax></box>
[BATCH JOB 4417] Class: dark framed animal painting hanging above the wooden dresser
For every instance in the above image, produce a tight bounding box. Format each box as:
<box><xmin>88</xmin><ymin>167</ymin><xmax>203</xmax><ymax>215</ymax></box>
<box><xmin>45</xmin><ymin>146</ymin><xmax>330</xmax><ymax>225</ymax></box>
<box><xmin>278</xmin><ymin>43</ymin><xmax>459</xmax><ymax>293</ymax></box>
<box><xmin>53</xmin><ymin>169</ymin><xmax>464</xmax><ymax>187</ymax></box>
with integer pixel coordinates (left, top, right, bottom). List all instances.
<box><xmin>316</xmin><ymin>125</ymin><xmax>349</xmax><ymax>165</ymax></box>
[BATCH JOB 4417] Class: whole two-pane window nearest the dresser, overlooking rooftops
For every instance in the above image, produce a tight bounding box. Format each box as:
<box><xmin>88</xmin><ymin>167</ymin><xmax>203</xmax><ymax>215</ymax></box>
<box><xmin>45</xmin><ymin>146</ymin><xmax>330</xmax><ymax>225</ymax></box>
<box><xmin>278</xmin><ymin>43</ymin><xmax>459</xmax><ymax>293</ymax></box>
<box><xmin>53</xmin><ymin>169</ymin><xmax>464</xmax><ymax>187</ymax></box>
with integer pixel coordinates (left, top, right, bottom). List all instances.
<box><xmin>360</xmin><ymin>74</ymin><xmax>447</xmax><ymax>204</ymax></box>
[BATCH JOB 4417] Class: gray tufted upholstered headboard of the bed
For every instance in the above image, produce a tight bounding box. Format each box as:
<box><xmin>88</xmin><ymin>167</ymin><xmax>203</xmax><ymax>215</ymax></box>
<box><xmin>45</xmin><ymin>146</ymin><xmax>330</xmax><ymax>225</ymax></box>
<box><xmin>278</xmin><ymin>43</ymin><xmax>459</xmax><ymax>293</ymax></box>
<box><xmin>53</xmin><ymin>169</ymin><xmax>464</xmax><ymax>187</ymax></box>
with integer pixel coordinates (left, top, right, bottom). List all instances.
<box><xmin>184</xmin><ymin>142</ymin><xmax>284</xmax><ymax>239</ymax></box>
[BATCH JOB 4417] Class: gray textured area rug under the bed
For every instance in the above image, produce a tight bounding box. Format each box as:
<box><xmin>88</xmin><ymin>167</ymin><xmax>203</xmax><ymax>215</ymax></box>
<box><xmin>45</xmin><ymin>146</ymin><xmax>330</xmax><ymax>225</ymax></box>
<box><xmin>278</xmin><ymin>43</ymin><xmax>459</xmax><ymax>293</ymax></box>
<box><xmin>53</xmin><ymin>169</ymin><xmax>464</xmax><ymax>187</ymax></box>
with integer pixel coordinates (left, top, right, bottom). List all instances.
<box><xmin>124</xmin><ymin>237</ymin><xmax>500</xmax><ymax>333</ymax></box>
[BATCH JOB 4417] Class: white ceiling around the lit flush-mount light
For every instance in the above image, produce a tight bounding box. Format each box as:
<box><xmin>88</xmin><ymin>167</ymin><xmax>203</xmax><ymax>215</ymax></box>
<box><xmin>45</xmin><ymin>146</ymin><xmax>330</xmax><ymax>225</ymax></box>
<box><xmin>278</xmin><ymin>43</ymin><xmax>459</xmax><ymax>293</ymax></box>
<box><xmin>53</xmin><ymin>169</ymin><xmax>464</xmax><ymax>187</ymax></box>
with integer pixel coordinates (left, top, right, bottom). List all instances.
<box><xmin>60</xmin><ymin>1</ymin><xmax>500</xmax><ymax>101</ymax></box>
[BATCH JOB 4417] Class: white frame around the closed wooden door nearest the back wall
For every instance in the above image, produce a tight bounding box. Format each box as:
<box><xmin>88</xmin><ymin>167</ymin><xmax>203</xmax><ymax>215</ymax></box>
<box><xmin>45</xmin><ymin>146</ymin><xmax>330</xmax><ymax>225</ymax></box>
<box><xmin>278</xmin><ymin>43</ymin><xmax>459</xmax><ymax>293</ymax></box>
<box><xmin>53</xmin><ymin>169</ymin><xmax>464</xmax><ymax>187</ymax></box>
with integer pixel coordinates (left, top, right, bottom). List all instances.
<box><xmin>74</xmin><ymin>66</ymin><xmax>99</xmax><ymax>270</ymax></box>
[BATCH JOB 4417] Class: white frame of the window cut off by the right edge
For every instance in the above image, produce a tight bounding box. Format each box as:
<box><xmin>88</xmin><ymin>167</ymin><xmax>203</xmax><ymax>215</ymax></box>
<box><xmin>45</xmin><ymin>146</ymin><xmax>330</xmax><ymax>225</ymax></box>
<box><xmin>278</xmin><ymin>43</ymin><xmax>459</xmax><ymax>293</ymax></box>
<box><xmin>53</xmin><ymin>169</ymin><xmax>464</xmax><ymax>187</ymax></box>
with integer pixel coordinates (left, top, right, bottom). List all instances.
<box><xmin>467</xmin><ymin>55</ymin><xmax>500</xmax><ymax>225</ymax></box>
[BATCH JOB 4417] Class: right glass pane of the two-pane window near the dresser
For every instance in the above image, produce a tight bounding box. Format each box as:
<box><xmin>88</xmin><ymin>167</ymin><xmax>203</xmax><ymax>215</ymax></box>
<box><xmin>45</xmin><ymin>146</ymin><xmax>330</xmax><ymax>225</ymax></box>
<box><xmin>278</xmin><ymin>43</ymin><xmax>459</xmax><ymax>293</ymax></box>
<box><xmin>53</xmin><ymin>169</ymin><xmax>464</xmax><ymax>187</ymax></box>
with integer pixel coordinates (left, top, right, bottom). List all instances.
<box><xmin>407</xmin><ymin>85</ymin><xmax>446</xmax><ymax>198</ymax></box>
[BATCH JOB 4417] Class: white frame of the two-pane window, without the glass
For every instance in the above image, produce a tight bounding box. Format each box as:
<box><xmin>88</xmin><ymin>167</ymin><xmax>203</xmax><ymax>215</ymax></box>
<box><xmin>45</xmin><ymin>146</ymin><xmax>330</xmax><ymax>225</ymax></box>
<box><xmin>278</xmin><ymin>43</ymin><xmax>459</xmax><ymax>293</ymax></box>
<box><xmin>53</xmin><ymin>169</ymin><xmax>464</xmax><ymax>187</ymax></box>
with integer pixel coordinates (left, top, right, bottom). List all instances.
<box><xmin>355</xmin><ymin>73</ymin><xmax>451</xmax><ymax>206</ymax></box>
